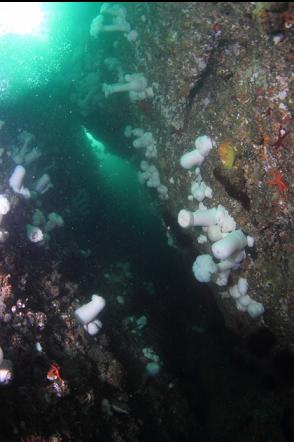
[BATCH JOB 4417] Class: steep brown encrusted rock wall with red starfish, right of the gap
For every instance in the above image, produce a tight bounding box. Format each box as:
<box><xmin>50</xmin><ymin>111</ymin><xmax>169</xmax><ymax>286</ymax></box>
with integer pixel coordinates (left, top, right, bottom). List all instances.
<box><xmin>84</xmin><ymin>2</ymin><xmax>294</xmax><ymax>349</ymax></box>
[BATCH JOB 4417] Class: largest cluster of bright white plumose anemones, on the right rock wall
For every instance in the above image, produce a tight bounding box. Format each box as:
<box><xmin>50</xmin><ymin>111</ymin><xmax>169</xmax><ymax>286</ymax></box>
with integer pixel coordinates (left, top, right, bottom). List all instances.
<box><xmin>178</xmin><ymin>135</ymin><xmax>264</xmax><ymax>318</ymax></box>
